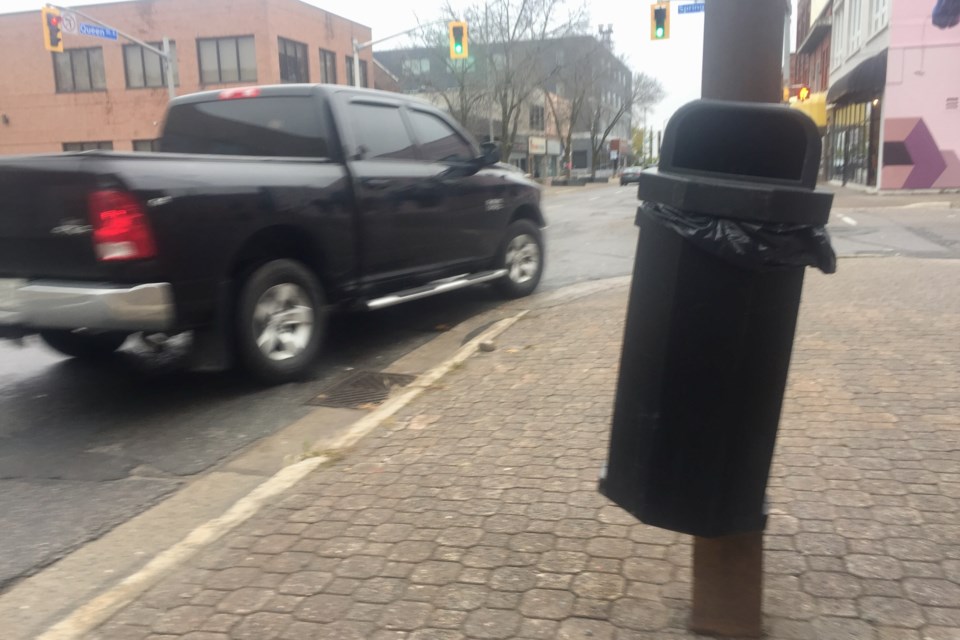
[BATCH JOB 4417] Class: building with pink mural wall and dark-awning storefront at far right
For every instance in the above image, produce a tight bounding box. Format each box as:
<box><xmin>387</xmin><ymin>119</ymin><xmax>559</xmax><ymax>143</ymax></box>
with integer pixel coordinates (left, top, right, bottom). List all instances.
<box><xmin>824</xmin><ymin>0</ymin><xmax>960</xmax><ymax>191</ymax></box>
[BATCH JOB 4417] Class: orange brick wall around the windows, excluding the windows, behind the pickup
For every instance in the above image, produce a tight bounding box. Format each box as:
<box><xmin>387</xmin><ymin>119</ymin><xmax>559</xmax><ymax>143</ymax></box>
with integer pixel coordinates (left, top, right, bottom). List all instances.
<box><xmin>0</xmin><ymin>0</ymin><xmax>373</xmax><ymax>154</ymax></box>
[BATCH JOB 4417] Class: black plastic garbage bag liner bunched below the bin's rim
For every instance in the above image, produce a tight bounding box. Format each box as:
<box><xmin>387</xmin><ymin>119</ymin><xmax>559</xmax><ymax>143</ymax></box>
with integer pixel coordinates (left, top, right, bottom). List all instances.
<box><xmin>637</xmin><ymin>202</ymin><xmax>837</xmax><ymax>273</ymax></box>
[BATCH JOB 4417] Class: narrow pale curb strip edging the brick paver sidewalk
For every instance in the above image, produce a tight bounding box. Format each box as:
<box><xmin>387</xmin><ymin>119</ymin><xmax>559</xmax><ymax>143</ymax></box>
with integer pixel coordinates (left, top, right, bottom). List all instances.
<box><xmin>38</xmin><ymin>310</ymin><xmax>527</xmax><ymax>640</ymax></box>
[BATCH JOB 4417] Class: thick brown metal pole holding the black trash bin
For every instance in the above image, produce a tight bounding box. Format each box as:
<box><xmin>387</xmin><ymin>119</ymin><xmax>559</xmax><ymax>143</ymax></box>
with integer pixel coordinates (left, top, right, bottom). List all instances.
<box><xmin>690</xmin><ymin>0</ymin><xmax>790</xmax><ymax>638</ymax></box>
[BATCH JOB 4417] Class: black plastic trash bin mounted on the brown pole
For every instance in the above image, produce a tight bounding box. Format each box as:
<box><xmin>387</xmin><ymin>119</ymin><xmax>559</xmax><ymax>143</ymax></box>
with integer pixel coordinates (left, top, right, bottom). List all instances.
<box><xmin>600</xmin><ymin>101</ymin><xmax>835</xmax><ymax>537</ymax></box>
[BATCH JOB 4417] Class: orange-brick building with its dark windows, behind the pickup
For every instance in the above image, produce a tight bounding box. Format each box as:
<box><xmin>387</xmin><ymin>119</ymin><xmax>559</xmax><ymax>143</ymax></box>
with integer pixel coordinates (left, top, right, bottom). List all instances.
<box><xmin>0</xmin><ymin>0</ymin><xmax>373</xmax><ymax>154</ymax></box>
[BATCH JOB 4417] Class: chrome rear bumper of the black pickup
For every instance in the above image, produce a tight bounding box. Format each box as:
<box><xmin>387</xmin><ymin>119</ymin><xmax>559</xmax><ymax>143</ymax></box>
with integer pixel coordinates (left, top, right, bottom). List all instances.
<box><xmin>0</xmin><ymin>278</ymin><xmax>175</xmax><ymax>337</ymax></box>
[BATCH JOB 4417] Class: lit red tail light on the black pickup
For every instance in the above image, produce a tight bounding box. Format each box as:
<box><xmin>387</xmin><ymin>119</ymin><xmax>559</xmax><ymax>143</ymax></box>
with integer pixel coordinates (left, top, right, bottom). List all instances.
<box><xmin>89</xmin><ymin>190</ymin><xmax>157</xmax><ymax>262</ymax></box>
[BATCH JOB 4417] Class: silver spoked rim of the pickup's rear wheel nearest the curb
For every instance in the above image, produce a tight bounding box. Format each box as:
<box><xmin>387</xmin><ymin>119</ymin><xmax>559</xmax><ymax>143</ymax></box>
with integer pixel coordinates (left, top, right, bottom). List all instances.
<box><xmin>253</xmin><ymin>282</ymin><xmax>314</xmax><ymax>361</ymax></box>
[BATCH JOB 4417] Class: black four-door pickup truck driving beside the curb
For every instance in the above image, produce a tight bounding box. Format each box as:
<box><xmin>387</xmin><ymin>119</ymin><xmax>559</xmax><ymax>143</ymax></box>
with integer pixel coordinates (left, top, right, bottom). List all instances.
<box><xmin>0</xmin><ymin>85</ymin><xmax>545</xmax><ymax>382</ymax></box>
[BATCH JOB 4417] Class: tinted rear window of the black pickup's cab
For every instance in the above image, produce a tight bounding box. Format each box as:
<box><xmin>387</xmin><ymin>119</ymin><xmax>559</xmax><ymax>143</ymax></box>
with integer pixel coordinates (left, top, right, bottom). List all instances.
<box><xmin>160</xmin><ymin>96</ymin><xmax>333</xmax><ymax>158</ymax></box>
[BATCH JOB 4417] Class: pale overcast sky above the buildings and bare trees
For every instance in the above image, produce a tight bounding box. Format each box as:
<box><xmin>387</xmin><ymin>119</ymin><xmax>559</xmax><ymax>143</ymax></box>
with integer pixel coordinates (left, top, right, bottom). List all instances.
<box><xmin>0</xmin><ymin>0</ymin><xmax>796</xmax><ymax>129</ymax></box>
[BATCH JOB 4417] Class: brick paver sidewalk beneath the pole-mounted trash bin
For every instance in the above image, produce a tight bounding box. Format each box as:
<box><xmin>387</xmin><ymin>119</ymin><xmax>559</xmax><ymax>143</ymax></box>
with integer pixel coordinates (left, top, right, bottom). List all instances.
<box><xmin>94</xmin><ymin>258</ymin><xmax>960</xmax><ymax>640</ymax></box>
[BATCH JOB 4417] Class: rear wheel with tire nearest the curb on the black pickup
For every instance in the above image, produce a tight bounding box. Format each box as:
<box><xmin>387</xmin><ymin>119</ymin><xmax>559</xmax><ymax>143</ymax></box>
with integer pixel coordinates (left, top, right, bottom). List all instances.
<box><xmin>237</xmin><ymin>260</ymin><xmax>326</xmax><ymax>384</ymax></box>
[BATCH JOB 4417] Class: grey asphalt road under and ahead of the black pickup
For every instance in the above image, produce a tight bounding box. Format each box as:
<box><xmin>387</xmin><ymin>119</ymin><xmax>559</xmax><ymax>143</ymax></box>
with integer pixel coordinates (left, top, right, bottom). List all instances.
<box><xmin>0</xmin><ymin>185</ymin><xmax>960</xmax><ymax>590</ymax></box>
